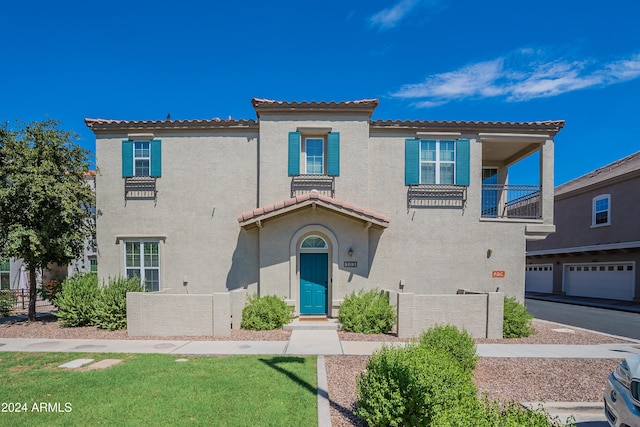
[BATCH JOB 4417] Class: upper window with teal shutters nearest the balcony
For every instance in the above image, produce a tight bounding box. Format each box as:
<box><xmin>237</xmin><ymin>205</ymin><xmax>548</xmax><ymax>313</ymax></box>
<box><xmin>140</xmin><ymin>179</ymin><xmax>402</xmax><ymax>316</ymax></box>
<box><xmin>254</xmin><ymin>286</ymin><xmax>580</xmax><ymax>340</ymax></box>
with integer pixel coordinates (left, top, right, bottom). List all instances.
<box><xmin>405</xmin><ymin>138</ymin><xmax>471</xmax><ymax>186</ymax></box>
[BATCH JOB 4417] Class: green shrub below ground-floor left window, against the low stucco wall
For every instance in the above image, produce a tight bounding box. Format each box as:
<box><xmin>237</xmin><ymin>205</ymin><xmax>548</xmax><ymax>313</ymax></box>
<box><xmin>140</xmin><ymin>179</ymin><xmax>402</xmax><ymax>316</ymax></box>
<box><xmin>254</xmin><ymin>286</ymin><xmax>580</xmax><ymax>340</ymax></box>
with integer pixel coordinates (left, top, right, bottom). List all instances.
<box><xmin>94</xmin><ymin>274</ymin><xmax>144</xmax><ymax>331</ymax></box>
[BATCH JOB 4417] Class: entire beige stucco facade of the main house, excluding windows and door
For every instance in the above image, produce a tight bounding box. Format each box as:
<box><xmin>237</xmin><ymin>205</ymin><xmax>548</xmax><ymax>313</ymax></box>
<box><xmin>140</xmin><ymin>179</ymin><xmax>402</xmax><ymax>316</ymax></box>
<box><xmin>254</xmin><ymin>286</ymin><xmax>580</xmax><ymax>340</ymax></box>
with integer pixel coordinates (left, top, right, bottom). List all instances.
<box><xmin>96</xmin><ymin>112</ymin><xmax>553</xmax><ymax>315</ymax></box>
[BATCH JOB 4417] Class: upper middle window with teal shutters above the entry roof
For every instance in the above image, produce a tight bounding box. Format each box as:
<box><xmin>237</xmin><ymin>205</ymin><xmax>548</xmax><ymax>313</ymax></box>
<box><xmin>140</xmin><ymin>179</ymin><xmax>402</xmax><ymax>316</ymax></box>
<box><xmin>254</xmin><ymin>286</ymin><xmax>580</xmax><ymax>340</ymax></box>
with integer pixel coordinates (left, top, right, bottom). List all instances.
<box><xmin>288</xmin><ymin>132</ymin><xmax>340</xmax><ymax>176</ymax></box>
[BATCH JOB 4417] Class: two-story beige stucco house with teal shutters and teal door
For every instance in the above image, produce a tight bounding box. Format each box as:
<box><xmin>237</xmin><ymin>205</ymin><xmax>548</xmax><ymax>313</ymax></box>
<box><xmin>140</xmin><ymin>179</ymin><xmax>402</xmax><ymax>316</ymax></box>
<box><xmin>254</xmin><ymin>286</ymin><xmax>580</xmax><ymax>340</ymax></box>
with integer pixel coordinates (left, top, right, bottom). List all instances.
<box><xmin>86</xmin><ymin>99</ymin><xmax>564</xmax><ymax>333</ymax></box>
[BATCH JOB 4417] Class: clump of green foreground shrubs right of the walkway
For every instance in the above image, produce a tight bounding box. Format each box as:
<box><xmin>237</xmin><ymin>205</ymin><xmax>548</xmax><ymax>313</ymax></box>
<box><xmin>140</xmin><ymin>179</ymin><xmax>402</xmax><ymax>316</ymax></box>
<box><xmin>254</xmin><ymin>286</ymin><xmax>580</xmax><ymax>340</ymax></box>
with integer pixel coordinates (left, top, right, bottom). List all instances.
<box><xmin>355</xmin><ymin>326</ymin><xmax>570</xmax><ymax>427</ymax></box>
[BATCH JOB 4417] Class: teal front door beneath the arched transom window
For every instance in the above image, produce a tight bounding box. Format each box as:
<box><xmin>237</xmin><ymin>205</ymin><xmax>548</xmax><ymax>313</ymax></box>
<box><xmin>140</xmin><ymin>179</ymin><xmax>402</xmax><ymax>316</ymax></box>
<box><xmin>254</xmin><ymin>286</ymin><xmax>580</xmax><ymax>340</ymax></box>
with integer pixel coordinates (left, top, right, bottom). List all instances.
<box><xmin>300</xmin><ymin>253</ymin><xmax>329</xmax><ymax>314</ymax></box>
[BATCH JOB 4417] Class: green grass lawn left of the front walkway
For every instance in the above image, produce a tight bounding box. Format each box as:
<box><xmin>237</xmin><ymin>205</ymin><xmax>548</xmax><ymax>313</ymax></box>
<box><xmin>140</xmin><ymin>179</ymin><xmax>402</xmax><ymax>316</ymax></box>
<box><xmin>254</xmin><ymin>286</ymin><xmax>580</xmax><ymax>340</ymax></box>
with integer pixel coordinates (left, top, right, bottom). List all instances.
<box><xmin>0</xmin><ymin>352</ymin><xmax>318</xmax><ymax>427</ymax></box>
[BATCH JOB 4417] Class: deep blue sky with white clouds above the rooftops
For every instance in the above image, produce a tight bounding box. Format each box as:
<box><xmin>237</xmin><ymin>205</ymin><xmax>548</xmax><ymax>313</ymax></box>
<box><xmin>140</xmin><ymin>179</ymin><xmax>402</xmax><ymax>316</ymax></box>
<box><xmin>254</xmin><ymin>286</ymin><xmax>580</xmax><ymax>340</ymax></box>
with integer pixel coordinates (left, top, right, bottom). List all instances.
<box><xmin>0</xmin><ymin>0</ymin><xmax>640</xmax><ymax>184</ymax></box>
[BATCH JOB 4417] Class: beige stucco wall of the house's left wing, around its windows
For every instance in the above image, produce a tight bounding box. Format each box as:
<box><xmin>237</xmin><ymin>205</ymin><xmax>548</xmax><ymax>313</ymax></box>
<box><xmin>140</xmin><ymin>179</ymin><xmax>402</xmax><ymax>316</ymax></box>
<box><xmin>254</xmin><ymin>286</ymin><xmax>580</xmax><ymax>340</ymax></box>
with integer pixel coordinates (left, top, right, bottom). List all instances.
<box><xmin>96</xmin><ymin>131</ymin><xmax>258</xmax><ymax>294</ymax></box>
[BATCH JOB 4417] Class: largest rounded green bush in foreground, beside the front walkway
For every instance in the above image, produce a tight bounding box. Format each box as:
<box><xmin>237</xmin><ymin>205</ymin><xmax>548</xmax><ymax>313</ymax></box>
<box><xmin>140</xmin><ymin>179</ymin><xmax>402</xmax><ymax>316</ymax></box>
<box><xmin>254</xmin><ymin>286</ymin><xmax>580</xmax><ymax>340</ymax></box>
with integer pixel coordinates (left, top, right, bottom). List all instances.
<box><xmin>356</xmin><ymin>345</ymin><xmax>477</xmax><ymax>426</ymax></box>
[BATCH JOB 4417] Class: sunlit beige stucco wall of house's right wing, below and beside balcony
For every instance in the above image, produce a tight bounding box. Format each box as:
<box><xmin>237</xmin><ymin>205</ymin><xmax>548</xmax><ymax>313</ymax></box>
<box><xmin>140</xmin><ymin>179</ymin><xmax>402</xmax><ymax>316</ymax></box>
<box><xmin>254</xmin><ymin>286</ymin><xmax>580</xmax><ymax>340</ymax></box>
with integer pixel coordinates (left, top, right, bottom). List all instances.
<box><xmin>369</xmin><ymin>134</ymin><xmax>525</xmax><ymax>299</ymax></box>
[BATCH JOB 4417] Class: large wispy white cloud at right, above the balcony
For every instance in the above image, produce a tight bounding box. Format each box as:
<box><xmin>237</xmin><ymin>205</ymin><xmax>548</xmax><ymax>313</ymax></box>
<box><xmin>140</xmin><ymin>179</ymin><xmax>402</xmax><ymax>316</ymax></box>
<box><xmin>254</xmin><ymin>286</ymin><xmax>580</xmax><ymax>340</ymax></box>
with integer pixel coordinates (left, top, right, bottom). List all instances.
<box><xmin>391</xmin><ymin>49</ymin><xmax>640</xmax><ymax>108</ymax></box>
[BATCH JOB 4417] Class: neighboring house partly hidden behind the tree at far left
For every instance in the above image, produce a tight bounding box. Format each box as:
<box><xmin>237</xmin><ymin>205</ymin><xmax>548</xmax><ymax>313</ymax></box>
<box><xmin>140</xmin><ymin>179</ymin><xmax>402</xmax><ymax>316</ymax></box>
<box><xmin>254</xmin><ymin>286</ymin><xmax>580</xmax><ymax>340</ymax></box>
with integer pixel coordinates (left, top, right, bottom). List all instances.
<box><xmin>0</xmin><ymin>170</ymin><xmax>98</xmax><ymax>290</ymax></box>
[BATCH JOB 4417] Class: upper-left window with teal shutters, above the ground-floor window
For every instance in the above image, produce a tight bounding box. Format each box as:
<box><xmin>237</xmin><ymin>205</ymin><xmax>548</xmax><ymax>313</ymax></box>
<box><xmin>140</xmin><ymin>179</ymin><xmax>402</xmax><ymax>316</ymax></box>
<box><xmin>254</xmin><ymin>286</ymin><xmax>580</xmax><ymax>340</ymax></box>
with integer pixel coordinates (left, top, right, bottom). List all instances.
<box><xmin>122</xmin><ymin>139</ymin><xmax>162</xmax><ymax>178</ymax></box>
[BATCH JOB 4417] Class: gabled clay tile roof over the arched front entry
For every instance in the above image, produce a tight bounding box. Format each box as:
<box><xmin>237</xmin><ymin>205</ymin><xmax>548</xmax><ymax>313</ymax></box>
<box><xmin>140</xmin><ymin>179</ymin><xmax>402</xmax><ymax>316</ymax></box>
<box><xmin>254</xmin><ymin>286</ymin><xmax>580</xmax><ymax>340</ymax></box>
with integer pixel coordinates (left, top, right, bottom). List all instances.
<box><xmin>237</xmin><ymin>191</ymin><xmax>391</xmax><ymax>228</ymax></box>
